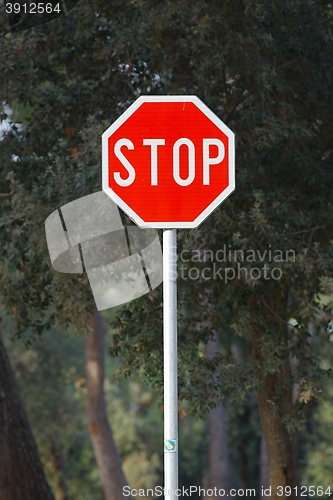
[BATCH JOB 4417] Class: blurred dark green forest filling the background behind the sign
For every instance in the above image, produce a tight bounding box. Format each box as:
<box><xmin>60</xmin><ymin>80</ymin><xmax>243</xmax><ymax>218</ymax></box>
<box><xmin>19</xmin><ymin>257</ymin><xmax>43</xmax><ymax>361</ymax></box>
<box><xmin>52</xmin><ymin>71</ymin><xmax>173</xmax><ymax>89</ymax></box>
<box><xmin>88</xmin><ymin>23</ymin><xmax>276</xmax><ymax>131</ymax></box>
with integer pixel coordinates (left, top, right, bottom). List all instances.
<box><xmin>0</xmin><ymin>0</ymin><xmax>333</xmax><ymax>500</ymax></box>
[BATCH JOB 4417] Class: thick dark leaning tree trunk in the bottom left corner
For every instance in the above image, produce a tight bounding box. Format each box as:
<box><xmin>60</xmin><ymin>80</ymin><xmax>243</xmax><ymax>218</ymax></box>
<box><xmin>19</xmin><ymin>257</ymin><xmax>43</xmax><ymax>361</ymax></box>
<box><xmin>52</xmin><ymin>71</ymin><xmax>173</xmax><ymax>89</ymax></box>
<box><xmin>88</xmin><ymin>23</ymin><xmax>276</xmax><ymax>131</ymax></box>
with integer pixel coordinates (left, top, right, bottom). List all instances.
<box><xmin>0</xmin><ymin>335</ymin><xmax>54</xmax><ymax>500</ymax></box>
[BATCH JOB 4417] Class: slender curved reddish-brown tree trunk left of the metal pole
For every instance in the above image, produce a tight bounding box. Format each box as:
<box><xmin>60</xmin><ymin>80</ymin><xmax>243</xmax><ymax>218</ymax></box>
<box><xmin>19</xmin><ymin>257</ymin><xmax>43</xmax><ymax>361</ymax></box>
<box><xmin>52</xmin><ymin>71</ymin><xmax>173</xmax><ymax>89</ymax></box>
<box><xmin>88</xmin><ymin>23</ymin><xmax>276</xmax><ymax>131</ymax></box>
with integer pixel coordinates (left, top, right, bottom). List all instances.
<box><xmin>86</xmin><ymin>311</ymin><xmax>130</xmax><ymax>500</ymax></box>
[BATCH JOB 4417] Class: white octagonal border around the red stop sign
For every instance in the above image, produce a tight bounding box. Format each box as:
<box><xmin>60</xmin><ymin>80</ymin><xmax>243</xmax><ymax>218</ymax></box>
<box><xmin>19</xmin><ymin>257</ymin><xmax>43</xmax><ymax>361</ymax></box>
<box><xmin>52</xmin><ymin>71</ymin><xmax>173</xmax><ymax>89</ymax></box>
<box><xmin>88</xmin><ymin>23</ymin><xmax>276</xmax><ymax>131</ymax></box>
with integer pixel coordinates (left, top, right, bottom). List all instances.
<box><xmin>102</xmin><ymin>95</ymin><xmax>235</xmax><ymax>229</ymax></box>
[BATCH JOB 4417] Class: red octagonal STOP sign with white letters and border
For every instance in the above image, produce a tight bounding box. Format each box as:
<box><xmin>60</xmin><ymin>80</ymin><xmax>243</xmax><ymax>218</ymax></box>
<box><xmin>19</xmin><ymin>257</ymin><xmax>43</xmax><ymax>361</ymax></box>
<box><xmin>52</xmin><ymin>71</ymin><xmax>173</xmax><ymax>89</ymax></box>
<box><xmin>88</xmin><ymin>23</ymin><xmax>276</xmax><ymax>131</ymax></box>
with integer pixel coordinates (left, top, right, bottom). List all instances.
<box><xmin>102</xmin><ymin>96</ymin><xmax>235</xmax><ymax>228</ymax></box>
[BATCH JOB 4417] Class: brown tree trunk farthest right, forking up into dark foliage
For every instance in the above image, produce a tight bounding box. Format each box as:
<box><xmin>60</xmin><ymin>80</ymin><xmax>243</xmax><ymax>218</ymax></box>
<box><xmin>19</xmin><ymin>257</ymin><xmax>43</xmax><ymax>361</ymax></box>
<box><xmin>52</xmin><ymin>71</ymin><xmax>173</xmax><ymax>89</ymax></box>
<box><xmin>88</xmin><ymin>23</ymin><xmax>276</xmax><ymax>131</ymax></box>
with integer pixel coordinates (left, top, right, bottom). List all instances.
<box><xmin>253</xmin><ymin>334</ymin><xmax>297</xmax><ymax>500</ymax></box>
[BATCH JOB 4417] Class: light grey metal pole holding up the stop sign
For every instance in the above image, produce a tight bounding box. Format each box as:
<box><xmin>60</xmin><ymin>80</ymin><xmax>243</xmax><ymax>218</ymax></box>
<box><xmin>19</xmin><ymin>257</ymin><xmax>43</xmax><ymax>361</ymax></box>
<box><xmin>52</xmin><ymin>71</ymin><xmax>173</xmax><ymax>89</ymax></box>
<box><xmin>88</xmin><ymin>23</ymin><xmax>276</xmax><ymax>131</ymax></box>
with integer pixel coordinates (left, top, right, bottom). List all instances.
<box><xmin>163</xmin><ymin>229</ymin><xmax>178</xmax><ymax>500</ymax></box>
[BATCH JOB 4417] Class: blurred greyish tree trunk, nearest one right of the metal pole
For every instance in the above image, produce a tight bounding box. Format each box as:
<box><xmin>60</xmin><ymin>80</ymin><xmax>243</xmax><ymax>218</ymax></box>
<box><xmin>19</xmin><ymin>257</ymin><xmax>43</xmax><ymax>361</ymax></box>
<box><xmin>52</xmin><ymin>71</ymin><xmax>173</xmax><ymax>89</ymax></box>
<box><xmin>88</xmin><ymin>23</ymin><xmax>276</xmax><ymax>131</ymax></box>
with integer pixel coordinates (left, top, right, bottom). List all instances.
<box><xmin>206</xmin><ymin>331</ymin><xmax>230</xmax><ymax>498</ymax></box>
